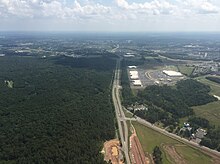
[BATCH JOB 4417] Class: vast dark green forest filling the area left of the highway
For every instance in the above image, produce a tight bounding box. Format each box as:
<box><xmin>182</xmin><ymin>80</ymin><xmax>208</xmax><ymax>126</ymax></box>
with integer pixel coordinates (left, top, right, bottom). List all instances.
<box><xmin>0</xmin><ymin>57</ymin><xmax>115</xmax><ymax>164</ymax></box>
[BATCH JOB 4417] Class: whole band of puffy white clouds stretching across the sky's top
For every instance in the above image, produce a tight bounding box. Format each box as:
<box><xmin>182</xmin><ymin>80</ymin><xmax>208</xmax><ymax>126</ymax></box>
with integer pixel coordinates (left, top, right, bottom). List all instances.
<box><xmin>0</xmin><ymin>0</ymin><xmax>219</xmax><ymax>19</ymax></box>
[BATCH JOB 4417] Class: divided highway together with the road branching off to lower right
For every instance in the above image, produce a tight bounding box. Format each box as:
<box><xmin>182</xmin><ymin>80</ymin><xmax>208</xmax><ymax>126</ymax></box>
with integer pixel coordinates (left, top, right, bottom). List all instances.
<box><xmin>112</xmin><ymin>59</ymin><xmax>220</xmax><ymax>164</ymax></box>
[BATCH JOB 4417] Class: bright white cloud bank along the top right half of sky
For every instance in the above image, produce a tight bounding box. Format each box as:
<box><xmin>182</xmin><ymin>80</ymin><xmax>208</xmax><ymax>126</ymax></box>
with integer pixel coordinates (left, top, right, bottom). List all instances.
<box><xmin>115</xmin><ymin>0</ymin><xmax>219</xmax><ymax>16</ymax></box>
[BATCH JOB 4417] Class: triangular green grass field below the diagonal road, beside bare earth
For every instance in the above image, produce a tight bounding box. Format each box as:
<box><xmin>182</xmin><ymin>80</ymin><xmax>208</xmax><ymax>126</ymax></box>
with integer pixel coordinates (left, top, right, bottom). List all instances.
<box><xmin>133</xmin><ymin>122</ymin><xmax>212</xmax><ymax>164</ymax></box>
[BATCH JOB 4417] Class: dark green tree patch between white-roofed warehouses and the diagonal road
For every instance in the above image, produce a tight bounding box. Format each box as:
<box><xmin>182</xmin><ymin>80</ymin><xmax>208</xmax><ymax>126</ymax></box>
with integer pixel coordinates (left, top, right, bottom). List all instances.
<box><xmin>138</xmin><ymin>79</ymin><xmax>216</xmax><ymax>121</ymax></box>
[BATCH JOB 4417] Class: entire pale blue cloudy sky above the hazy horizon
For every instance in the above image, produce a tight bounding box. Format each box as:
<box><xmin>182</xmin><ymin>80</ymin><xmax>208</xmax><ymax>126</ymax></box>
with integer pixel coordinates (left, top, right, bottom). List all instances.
<box><xmin>0</xmin><ymin>0</ymin><xmax>220</xmax><ymax>32</ymax></box>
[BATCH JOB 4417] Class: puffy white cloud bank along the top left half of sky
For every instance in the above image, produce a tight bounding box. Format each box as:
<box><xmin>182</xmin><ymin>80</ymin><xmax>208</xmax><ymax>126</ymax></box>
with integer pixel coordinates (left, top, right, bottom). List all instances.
<box><xmin>0</xmin><ymin>0</ymin><xmax>111</xmax><ymax>19</ymax></box>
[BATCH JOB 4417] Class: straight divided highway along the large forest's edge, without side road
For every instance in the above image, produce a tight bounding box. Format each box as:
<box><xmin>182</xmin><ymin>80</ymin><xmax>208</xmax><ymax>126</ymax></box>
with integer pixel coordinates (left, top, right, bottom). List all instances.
<box><xmin>112</xmin><ymin>59</ymin><xmax>131</xmax><ymax>164</ymax></box>
